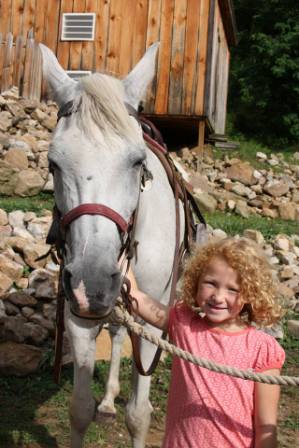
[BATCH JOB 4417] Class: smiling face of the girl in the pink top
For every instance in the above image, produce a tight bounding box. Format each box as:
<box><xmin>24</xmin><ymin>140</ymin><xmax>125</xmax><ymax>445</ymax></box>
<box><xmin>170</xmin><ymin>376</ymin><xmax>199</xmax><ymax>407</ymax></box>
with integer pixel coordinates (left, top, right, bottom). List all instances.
<box><xmin>196</xmin><ymin>256</ymin><xmax>243</xmax><ymax>331</ymax></box>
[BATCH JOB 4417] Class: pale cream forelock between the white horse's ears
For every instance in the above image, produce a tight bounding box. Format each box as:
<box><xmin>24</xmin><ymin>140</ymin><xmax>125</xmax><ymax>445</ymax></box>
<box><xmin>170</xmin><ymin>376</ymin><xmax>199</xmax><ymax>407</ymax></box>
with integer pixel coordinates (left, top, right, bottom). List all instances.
<box><xmin>76</xmin><ymin>73</ymin><xmax>136</xmax><ymax>140</ymax></box>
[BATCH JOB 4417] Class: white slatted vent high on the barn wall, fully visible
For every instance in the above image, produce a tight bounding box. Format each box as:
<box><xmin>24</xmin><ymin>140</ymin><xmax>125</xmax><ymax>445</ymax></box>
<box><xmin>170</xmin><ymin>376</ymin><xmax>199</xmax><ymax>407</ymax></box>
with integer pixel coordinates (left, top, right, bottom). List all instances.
<box><xmin>61</xmin><ymin>12</ymin><xmax>96</xmax><ymax>40</ymax></box>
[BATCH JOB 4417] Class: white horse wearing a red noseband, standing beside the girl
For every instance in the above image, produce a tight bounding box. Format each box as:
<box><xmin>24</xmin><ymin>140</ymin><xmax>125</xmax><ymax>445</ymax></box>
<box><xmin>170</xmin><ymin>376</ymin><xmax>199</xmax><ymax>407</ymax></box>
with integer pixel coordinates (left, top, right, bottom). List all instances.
<box><xmin>40</xmin><ymin>44</ymin><xmax>184</xmax><ymax>448</ymax></box>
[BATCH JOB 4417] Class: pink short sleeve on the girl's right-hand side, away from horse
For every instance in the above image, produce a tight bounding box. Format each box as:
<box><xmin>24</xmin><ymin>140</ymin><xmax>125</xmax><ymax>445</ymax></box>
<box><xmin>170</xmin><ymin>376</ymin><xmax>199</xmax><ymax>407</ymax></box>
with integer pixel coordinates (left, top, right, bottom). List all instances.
<box><xmin>254</xmin><ymin>334</ymin><xmax>285</xmax><ymax>372</ymax></box>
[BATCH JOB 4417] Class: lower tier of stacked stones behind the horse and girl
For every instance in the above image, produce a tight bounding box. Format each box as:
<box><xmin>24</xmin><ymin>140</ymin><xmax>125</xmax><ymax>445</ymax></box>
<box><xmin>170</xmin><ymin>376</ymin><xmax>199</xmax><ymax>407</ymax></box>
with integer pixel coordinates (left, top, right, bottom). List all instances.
<box><xmin>0</xmin><ymin>209</ymin><xmax>299</xmax><ymax>374</ymax></box>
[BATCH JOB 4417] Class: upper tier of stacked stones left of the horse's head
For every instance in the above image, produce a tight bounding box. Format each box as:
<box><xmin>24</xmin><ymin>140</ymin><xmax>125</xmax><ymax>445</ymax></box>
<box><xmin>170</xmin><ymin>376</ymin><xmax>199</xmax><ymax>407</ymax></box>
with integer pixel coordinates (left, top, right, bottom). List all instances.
<box><xmin>0</xmin><ymin>88</ymin><xmax>57</xmax><ymax>196</ymax></box>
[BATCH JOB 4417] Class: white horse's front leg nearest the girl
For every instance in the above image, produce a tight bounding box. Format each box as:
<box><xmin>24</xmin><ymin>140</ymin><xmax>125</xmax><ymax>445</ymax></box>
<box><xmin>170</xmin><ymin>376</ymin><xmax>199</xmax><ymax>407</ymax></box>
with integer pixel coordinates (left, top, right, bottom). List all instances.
<box><xmin>126</xmin><ymin>334</ymin><xmax>161</xmax><ymax>448</ymax></box>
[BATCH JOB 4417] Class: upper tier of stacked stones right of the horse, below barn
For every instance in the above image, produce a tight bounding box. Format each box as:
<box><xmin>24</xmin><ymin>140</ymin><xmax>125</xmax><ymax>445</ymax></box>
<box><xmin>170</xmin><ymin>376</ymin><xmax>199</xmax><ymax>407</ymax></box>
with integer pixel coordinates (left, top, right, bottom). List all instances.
<box><xmin>173</xmin><ymin>148</ymin><xmax>299</xmax><ymax>222</ymax></box>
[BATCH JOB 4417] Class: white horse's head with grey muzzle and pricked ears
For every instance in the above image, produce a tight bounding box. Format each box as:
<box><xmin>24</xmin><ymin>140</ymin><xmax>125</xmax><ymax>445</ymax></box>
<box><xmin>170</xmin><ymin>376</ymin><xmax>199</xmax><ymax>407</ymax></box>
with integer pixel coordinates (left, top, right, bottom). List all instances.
<box><xmin>40</xmin><ymin>44</ymin><xmax>158</xmax><ymax>317</ymax></box>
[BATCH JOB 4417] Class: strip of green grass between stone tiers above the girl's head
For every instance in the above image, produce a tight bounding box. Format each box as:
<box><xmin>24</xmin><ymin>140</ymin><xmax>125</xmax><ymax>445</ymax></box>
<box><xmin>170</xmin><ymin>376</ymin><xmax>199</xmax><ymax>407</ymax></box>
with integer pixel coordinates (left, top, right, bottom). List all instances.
<box><xmin>205</xmin><ymin>211</ymin><xmax>299</xmax><ymax>240</ymax></box>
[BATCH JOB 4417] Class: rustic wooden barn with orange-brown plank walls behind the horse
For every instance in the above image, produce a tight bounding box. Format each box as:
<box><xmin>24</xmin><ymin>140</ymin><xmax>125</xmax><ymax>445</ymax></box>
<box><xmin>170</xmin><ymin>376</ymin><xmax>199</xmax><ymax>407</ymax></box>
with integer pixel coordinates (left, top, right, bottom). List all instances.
<box><xmin>0</xmin><ymin>0</ymin><xmax>236</xmax><ymax>145</ymax></box>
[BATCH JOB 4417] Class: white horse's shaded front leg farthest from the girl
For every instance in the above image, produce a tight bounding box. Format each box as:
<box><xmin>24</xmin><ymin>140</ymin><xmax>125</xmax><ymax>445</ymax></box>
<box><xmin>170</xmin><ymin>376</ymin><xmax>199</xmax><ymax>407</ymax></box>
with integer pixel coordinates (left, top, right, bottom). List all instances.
<box><xmin>65</xmin><ymin>305</ymin><xmax>99</xmax><ymax>448</ymax></box>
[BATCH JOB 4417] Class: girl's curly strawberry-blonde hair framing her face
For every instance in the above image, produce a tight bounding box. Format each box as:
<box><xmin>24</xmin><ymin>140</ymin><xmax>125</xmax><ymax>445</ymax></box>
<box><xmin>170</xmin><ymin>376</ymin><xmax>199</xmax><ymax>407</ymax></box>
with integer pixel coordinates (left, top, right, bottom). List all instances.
<box><xmin>181</xmin><ymin>238</ymin><xmax>283</xmax><ymax>326</ymax></box>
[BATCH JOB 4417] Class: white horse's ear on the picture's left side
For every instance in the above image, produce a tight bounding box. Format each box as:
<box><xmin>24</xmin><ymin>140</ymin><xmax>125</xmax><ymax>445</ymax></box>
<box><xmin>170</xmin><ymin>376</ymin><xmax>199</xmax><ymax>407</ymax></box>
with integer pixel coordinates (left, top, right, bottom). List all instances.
<box><xmin>39</xmin><ymin>44</ymin><xmax>77</xmax><ymax>106</ymax></box>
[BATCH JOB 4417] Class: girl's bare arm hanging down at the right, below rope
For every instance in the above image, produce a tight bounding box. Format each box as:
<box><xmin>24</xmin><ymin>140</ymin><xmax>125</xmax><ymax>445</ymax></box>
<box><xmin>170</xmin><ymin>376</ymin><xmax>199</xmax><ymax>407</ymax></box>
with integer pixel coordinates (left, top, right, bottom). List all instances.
<box><xmin>254</xmin><ymin>369</ymin><xmax>280</xmax><ymax>448</ymax></box>
